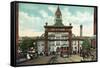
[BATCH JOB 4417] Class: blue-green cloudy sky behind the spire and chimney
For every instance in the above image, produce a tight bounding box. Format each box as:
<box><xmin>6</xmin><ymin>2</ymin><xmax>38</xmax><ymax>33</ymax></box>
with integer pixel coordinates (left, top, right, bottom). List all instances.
<box><xmin>19</xmin><ymin>3</ymin><xmax>94</xmax><ymax>37</ymax></box>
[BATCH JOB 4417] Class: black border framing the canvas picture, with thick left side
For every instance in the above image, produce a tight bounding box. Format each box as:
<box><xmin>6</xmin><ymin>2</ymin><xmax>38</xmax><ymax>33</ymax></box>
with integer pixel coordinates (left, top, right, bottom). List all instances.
<box><xmin>10</xmin><ymin>1</ymin><xmax>98</xmax><ymax>67</ymax></box>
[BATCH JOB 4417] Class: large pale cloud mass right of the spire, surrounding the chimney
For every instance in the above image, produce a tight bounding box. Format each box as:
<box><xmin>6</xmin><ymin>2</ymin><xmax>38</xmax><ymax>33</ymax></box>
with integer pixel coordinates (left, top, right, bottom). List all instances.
<box><xmin>62</xmin><ymin>8</ymin><xmax>93</xmax><ymax>36</ymax></box>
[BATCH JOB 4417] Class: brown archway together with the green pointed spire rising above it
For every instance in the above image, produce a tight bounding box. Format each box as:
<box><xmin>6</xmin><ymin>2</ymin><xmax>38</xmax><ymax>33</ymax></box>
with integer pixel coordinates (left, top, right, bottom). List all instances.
<box><xmin>44</xmin><ymin>6</ymin><xmax>72</xmax><ymax>56</ymax></box>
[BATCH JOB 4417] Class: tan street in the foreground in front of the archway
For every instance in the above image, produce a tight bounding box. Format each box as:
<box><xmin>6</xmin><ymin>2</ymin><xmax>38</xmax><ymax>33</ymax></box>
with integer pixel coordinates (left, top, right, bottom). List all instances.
<box><xmin>18</xmin><ymin>55</ymin><xmax>96</xmax><ymax>65</ymax></box>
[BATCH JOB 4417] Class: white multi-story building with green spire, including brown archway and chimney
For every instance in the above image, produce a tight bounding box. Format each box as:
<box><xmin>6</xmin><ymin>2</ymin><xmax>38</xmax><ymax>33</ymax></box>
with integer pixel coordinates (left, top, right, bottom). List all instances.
<box><xmin>37</xmin><ymin>6</ymin><xmax>92</xmax><ymax>55</ymax></box>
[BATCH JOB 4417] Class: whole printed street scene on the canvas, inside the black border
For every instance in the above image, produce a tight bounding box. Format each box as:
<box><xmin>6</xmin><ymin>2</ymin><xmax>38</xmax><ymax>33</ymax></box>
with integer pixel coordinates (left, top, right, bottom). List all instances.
<box><xmin>13</xmin><ymin>2</ymin><xmax>97</xmax><ymax>66</ymax></box>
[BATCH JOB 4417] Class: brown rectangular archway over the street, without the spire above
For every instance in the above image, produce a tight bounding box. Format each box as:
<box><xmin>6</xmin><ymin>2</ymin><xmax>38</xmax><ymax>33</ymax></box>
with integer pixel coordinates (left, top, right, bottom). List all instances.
<box><xmin>44</xmin><ymin>25</ymin><xmax>72</xmax><ymax>55</ymax></box>
